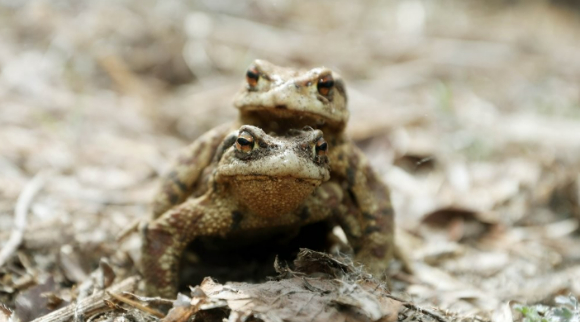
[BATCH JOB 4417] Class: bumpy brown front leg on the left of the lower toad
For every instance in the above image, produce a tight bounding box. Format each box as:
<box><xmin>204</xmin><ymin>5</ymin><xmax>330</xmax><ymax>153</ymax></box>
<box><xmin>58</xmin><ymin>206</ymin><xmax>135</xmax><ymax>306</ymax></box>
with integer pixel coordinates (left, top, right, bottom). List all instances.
<box><xmin>141</xmin><ymin>196</ymin><xmax>232</xmax><ymax>298</ymax></box>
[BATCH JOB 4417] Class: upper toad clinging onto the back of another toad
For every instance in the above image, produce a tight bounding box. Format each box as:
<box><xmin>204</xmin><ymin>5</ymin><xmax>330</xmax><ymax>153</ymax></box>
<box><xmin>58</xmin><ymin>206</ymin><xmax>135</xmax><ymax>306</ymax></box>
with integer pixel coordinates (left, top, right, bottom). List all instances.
<box><xmin>144</xmin><ymin>60</ymin><xmax>394</xmax><ymax>296</ymax></box>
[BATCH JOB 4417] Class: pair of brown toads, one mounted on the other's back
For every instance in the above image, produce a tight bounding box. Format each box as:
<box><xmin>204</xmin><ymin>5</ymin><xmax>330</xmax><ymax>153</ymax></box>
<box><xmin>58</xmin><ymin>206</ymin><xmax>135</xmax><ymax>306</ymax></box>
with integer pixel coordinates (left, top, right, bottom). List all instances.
<box><xmin>142</xmin><ymin>60</ymin><xmax>394</xmax><ymax>297</ymax></box>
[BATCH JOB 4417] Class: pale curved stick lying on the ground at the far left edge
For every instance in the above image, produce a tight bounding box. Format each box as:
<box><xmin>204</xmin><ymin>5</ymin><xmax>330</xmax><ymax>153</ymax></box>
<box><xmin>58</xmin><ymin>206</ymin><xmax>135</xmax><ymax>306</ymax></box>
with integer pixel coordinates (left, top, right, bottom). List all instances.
<box><xmin>0</xmin><ymin>172</ymin><xmax>47</xmax><ymax>267</ymax></box>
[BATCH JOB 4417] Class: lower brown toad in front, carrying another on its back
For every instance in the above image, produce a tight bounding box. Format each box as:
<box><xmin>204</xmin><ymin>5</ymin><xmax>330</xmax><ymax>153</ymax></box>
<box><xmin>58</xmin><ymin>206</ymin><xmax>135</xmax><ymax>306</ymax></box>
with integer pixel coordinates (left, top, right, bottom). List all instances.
<box><xmin>142</xmin><ymin>125</ymin><xmax>342</xmax><ymax>297</ymax></box>
